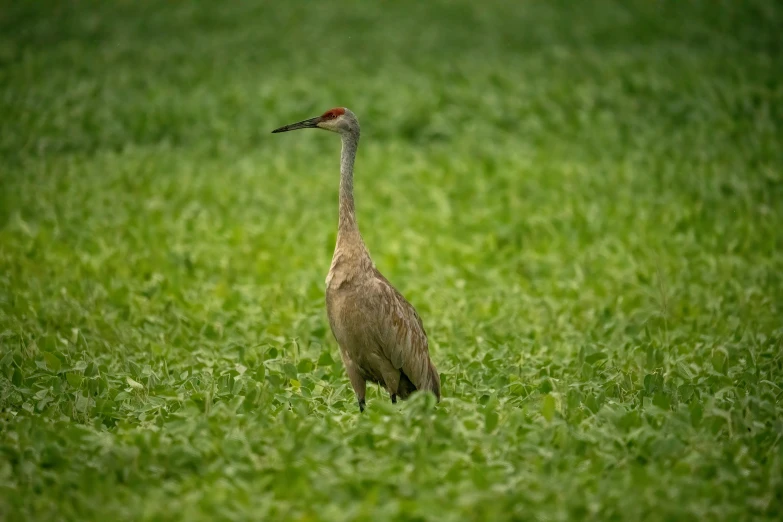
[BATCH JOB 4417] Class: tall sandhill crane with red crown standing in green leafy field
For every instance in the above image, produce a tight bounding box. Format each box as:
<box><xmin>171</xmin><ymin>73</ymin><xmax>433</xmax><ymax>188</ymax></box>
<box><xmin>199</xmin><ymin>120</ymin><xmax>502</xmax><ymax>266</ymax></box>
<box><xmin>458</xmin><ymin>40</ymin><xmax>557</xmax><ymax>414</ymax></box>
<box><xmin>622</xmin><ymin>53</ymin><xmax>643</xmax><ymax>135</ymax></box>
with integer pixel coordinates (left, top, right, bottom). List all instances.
<box><xmin>272</xmin><ymin>107</ymin><xmax>441</xmax><ymax>412</ymax></box>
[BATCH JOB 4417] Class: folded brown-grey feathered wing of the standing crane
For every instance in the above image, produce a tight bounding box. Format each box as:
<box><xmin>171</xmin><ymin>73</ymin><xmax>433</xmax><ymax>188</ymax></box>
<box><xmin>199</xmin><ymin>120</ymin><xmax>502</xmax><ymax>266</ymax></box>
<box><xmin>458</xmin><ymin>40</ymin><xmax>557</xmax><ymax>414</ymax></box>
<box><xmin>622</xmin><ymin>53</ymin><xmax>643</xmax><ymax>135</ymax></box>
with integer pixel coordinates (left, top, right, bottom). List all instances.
<box><xmin>374</xmin><ymin>270</ymin><xmax>440</xmax><ymax>390</ymax></box>
